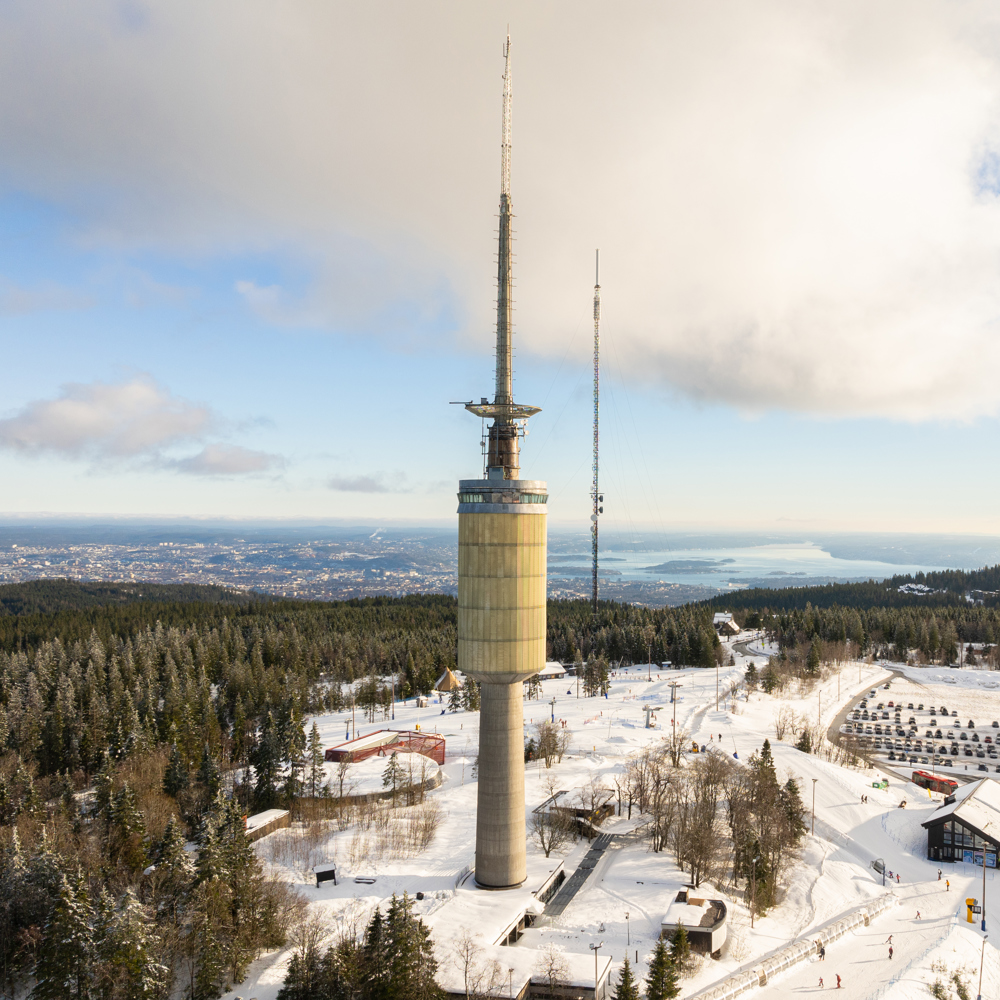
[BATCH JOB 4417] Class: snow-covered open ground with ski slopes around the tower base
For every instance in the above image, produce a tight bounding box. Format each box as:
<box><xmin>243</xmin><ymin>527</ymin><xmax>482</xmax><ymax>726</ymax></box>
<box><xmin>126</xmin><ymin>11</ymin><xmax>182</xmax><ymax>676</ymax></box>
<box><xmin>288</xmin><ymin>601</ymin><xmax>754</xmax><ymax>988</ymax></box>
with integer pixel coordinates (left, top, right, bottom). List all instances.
<box><xmin>227</xmin><ymin>649</ymin><xmax>1000</xmax><ymax>1000</ymax></box>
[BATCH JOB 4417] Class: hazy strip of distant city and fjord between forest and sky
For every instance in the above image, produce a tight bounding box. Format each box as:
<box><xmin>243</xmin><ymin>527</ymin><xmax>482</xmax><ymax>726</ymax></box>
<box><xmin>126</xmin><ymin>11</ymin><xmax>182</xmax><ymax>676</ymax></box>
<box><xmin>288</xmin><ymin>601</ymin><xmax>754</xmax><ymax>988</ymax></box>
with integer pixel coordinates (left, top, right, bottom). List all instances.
<box><xmin>0</xmin><ymin>521</ymin><xmax>1000</xmax><ymax>607</ymax></box>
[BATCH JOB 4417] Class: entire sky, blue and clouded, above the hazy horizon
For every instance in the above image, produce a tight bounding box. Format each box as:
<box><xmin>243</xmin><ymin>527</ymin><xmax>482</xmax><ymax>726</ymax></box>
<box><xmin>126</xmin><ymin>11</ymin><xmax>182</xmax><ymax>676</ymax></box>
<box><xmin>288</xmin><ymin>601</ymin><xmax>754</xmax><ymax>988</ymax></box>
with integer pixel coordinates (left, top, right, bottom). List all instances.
<box><xmin>0</xmin><ymin>0</ymin><xmax>1000</xmax><ymax>532</ymax></box>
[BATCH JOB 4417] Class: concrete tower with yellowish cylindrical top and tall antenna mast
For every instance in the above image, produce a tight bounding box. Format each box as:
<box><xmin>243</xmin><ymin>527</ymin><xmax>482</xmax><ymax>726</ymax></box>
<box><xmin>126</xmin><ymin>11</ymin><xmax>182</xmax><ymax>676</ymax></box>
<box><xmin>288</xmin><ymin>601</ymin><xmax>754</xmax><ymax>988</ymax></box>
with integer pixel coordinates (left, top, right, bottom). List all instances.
<box><xmin>458</xmin><ymin>36</ymin><xmax>548</xmax><ymax>889</ymax></box>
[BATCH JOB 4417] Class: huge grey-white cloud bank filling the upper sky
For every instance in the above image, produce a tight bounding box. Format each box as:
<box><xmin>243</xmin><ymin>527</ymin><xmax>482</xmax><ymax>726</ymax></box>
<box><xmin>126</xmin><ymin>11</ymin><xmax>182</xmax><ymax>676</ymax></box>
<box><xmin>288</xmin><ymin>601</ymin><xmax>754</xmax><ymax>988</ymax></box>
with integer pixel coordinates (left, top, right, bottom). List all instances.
<box><xmin>0</xmin><ymin>0</ymin><xmax>1000</xmax><ymax>418</ymax></box>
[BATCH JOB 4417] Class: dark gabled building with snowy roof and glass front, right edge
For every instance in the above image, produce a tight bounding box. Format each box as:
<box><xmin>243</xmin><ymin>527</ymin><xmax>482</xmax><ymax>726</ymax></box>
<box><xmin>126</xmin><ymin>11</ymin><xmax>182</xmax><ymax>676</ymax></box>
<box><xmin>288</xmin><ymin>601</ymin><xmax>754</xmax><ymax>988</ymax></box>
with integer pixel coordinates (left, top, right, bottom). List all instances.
<box><xmin>922</xmin><ymin>778</ymin><xmax>1000</xmax><ymax>868</ymax></box>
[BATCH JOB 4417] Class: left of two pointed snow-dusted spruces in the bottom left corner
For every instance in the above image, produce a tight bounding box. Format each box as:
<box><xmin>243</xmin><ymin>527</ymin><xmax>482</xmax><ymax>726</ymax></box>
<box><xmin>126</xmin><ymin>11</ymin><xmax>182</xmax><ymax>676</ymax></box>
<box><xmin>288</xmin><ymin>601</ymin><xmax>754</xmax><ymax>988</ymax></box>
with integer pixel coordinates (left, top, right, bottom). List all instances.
<box><xmin>31</xmin><ymin>872</ymin><xmax>95</xmax><ymax>1000</ymax></box>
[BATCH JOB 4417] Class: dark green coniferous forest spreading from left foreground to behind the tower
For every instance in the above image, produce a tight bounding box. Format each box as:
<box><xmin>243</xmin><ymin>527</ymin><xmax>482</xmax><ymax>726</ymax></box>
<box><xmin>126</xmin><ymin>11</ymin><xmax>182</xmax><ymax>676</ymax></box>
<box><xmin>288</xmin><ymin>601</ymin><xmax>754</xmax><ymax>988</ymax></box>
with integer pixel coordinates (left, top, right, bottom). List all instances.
<box><xmin>0</xmin><ymin>577</ymin><xmax>1000</xmax><ymax>1000</ymax></box>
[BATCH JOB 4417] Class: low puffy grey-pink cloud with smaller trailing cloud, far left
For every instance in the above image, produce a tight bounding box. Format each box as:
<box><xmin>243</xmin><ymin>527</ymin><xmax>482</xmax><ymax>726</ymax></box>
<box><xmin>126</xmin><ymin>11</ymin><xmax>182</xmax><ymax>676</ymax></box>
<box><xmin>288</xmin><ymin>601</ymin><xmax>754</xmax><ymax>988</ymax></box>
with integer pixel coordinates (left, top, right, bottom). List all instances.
<box><xmin>0</xmin><ymin>375</ymin><xmax>281</xmax><ymax>475</ymax></box>
